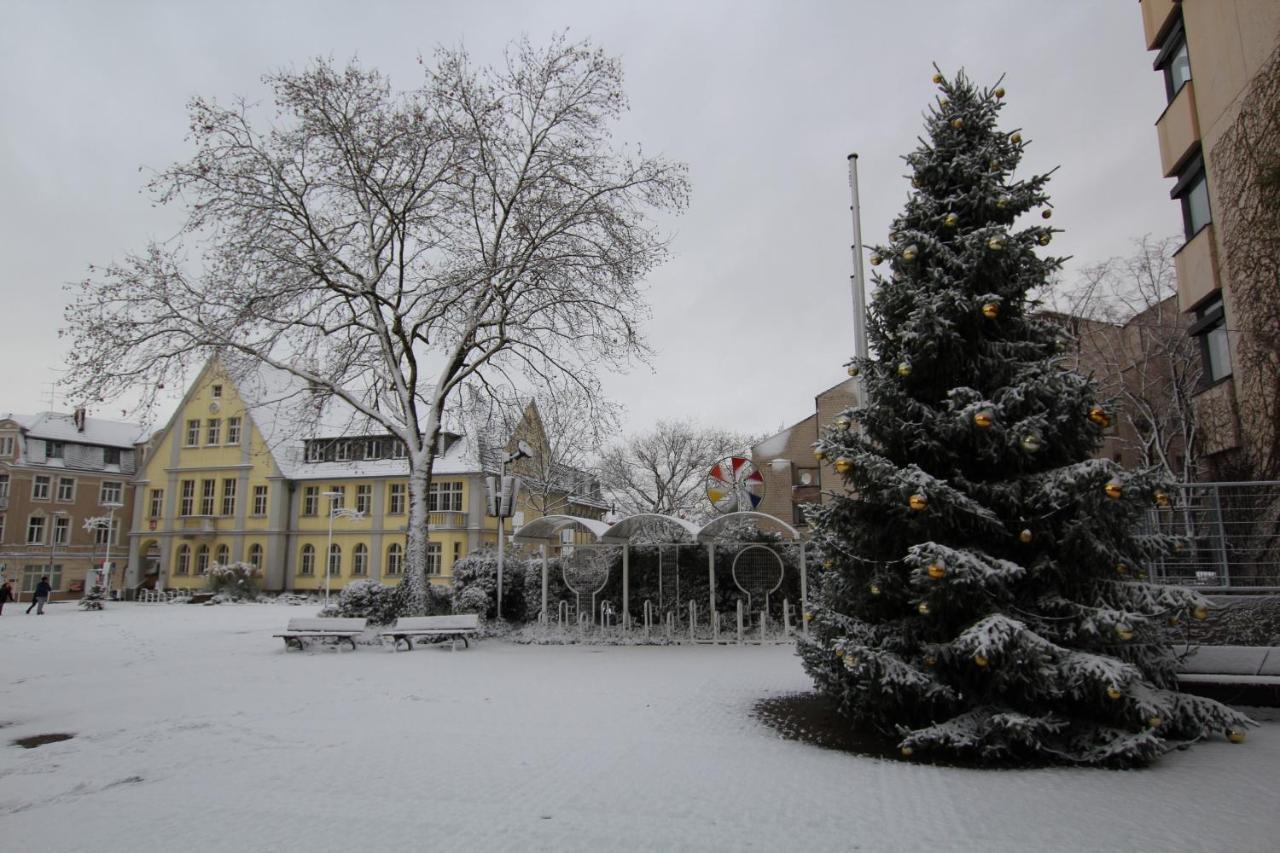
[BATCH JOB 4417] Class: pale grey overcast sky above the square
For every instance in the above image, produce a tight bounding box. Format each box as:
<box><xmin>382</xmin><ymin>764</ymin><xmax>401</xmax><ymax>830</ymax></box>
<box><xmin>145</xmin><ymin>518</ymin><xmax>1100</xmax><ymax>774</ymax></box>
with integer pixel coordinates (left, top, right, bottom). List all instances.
<box><xmin>0</xmin><ymin>0</ymin><xmax>1179</xmax><ymax>433</ymax></box>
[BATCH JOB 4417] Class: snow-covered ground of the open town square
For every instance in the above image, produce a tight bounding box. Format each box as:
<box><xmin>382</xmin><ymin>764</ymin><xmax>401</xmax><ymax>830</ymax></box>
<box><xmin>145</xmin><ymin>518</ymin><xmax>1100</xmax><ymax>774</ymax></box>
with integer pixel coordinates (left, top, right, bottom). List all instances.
<box><xmin>0</xmin><ymin>605</ymin><xmax>1280</xmax><ymax>853</ymax></box>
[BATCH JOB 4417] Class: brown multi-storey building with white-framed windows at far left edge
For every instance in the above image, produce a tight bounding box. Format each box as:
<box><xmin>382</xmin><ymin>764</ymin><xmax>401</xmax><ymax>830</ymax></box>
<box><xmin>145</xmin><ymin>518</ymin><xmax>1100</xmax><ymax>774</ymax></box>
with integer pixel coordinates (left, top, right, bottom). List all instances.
<box><xmin>0</xmin><ymin>409</ymin><xmax>142</xmax><ymax>599</ymax></box>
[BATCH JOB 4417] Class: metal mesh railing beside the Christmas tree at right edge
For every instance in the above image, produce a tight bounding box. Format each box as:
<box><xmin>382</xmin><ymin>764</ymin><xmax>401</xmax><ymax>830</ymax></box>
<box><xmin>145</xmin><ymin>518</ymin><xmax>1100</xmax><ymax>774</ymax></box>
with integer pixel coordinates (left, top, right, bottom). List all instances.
<box><xmin>1147</xmin><ymin>480</ymin><xmax>1280</xmax><ymax>589</ymax></box>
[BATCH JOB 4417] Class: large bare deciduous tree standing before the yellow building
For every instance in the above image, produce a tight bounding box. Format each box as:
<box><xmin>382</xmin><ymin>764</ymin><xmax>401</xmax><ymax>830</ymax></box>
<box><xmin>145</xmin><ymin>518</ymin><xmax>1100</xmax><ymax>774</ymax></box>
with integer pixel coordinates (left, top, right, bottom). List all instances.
<box><xmin>65</xmin><ymin>37</ymin><xmax>687</xmax><ymax>611</ymax></box>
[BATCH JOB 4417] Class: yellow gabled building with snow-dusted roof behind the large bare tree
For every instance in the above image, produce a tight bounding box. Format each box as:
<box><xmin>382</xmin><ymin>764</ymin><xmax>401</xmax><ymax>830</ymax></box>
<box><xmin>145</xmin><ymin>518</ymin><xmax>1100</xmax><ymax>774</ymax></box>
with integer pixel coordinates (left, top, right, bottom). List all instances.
<box><xmin>127</xmin><ymin>360</ymin><xmax>605</xmax><ymax>592</ymax></box>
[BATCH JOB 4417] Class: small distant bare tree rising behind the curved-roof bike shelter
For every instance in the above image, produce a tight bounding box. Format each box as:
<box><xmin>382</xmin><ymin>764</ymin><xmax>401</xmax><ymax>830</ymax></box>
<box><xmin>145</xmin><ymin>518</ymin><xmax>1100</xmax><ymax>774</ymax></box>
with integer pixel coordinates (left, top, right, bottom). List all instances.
<box><xmin>600</xmin><ymin>421</ymin><xmax>754</xmax><ymax>521</ymax></box>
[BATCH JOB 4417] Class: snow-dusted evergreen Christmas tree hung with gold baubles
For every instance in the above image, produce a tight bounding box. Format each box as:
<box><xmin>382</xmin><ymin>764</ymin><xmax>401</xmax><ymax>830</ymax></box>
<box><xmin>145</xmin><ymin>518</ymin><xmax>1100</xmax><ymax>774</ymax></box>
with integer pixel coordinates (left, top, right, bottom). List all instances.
<box><xmin>800</xmin><ymin>73</ymin><xmax>1249</xmax><ymax>765</ymax></box>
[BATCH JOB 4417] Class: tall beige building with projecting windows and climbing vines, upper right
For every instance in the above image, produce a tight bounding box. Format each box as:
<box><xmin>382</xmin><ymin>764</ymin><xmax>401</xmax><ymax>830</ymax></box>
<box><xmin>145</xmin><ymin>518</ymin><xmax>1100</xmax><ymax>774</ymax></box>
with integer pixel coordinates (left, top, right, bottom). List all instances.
<box><xmin>1140</xmin><ymin>0</ymin><xmax>1280</xmax><ymax>479</ymax></box>
